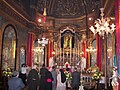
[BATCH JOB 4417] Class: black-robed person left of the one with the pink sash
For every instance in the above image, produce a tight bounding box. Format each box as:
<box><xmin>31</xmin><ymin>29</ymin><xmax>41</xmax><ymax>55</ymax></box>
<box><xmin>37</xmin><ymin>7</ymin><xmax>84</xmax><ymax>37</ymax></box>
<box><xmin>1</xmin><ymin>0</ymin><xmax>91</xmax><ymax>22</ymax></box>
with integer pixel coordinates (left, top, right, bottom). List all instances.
<box><xmin>27</xmin><ymin>65</ymin><xmax>39</xmax><ymax>90</ymax></box>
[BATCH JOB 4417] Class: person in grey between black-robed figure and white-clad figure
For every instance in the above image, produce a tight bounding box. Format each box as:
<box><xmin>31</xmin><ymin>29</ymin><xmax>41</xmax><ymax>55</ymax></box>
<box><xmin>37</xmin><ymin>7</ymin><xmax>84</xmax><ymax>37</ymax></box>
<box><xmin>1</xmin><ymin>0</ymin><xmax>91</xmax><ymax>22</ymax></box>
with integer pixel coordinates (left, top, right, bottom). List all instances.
<box><xmin>51</xmin><ymin>66</ymin><xmax>57</xmax><ymax>90</ymax></box>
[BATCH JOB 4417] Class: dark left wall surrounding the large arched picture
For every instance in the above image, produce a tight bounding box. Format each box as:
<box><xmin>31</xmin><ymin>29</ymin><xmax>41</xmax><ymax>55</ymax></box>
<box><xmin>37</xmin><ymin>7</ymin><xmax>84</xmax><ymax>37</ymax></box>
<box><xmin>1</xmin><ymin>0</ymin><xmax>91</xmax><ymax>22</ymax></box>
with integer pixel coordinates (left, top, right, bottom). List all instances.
<box><xmin>0</xmin><ymin>14</ymin><xmax>28</xmax><ymax>69</ymax></box>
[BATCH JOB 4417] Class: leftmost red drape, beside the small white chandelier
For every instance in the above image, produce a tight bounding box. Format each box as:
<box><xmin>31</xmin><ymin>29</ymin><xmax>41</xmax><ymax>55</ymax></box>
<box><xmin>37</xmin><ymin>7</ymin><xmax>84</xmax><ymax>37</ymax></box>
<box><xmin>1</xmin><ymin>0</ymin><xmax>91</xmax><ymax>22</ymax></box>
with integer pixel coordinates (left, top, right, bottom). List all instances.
<box><xmin>26</xmin><ymin>32</ymin><xmax>34</xmax><ymax>67</ymax></box>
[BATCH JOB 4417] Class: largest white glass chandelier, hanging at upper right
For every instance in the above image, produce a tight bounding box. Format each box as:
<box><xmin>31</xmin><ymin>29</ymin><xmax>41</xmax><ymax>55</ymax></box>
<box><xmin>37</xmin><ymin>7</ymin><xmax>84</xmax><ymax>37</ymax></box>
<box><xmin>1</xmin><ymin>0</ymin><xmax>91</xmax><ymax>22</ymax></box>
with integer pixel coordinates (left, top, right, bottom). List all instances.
<box><xmin>90</xmin><ymin>8</ymin><xmax>115</xmax><ymax>39</ymax></box>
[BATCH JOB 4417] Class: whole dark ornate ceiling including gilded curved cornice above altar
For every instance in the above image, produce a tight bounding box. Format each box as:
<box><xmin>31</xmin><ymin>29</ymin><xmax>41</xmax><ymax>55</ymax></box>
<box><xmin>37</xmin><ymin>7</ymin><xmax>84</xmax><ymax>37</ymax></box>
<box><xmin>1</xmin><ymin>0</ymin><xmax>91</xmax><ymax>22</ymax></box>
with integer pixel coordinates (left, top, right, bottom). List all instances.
<box><xmin>1</xmin><ymin>0</ymin><xmax>114</xmax><ymax>39</ymax></box>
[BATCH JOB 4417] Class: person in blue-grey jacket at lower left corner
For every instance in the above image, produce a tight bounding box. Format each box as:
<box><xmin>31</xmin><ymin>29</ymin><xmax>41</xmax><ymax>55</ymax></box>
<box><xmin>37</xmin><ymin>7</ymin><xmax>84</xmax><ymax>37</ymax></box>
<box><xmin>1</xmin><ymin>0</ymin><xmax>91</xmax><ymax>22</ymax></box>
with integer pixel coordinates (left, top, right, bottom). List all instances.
<box><xmin>8</xmin><ymin>71</ymin><xmax>25</xmax><ymax>90</ymax></box>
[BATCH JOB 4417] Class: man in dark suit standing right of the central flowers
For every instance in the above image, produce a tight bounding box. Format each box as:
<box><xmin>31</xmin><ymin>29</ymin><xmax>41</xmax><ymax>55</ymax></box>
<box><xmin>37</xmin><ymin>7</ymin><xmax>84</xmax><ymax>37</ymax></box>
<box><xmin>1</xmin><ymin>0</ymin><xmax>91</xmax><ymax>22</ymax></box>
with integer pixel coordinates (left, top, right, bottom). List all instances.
<box><xmin>71</xmin><ymin>68</ymin><xmax>80</xmax><ymax>90</ymax></box>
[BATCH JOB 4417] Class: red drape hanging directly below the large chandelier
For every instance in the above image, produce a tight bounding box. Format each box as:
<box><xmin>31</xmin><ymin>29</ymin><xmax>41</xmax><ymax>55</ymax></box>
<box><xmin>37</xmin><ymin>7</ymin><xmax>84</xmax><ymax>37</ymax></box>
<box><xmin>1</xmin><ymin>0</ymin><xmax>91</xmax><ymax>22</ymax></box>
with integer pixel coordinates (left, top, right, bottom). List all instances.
<box><xmin>96</xmin><ymin>34</ymin><xmax>102</xmax><ymax>71</ymax></box>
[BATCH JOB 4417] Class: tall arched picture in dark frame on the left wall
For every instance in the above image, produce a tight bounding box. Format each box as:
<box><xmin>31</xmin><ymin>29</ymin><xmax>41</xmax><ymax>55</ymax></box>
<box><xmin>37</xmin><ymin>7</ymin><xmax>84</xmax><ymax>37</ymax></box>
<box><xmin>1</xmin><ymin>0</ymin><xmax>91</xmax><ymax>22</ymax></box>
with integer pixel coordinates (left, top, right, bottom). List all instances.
<box><xmin>2</xmin><ymin>25</ymin><xmax>16</xmax><ymax>69</ymax></box>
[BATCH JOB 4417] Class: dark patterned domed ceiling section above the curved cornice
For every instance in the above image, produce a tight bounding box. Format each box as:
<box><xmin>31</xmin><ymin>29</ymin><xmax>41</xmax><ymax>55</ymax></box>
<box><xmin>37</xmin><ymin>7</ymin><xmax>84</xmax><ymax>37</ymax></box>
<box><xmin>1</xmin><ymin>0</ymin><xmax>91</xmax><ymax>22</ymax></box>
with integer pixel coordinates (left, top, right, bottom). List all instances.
<box><xmin>37</xmin><ymin>0</ymin><xmax>101</xmax><ymax>18</ymax></box>
